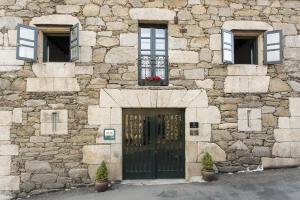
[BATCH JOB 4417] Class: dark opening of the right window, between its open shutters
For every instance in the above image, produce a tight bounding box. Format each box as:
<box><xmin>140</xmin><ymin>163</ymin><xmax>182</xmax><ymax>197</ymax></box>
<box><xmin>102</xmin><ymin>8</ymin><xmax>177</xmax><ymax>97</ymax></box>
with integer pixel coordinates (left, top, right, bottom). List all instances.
<box><xmin>234</xmin><ymin>36</ymin><xmax>258</xmax><ymax>64</ymax></box>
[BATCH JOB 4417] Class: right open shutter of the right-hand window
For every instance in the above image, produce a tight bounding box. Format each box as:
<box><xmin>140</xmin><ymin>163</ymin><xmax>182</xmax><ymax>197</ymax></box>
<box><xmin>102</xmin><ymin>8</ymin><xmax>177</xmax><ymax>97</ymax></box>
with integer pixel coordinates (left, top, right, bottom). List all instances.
<box><xmin>264</xmin><ymin>30</ymin><xmax>282</xmax><ymax>64</ymax></box>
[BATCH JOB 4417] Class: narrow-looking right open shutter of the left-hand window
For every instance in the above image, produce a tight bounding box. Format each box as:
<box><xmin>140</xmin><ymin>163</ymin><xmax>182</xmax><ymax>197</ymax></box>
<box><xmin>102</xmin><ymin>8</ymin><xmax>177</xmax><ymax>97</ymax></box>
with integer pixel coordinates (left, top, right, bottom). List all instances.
<box><xmin>70</xmin><ymin>23</ymin><xmax>79</xmax><ymax>61</ymax></box>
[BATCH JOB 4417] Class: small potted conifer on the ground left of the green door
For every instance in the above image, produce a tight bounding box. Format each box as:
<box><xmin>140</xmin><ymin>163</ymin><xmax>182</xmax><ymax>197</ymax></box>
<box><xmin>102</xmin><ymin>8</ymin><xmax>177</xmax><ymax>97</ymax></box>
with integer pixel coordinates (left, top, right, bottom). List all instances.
<box><xmin>95</xmin><ymin>161</ymin><xmax>108</xmax><ymax>192</ymax></box>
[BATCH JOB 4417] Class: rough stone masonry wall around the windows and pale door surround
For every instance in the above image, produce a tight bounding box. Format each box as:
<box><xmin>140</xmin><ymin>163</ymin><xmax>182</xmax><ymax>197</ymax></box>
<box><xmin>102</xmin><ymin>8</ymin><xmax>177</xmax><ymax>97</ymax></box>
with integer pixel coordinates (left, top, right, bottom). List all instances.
<box><xmin>0</xmin><ymin>0</ymin><xmax>300</xmax><ymax>198</ymax></box>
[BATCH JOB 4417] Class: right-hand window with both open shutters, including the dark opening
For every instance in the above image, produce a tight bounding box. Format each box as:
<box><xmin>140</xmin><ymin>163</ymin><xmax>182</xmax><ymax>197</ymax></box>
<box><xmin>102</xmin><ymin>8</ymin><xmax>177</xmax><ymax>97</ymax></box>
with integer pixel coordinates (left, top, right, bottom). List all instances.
<box><xmin>222</xmin><ymin>29</ymin><xmax>282</xmax><ymax>65</ymax></box>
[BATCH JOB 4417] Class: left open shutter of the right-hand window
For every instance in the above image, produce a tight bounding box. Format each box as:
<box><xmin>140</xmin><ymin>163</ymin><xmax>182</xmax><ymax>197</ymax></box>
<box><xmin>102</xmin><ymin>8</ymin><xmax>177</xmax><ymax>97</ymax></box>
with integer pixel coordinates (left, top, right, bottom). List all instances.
<box><xmin>222</xmin><ymin>29</ymin><xmax>234</xmax><ymax>64</ymax></box>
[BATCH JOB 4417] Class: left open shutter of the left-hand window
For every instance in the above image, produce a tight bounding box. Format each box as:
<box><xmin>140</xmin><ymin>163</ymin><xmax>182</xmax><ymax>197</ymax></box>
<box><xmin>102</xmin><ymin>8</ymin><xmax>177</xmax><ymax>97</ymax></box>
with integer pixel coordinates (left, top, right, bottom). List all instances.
<box><xmin>17</xmin><ymin>24</ymin><xmax>38</xmax><ymax>61</ymax></box>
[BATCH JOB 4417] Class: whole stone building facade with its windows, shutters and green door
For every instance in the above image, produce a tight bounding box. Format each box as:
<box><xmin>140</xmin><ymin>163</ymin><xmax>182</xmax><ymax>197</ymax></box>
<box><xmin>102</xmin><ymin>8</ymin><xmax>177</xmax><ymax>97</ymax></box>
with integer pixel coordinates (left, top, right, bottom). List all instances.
<box><xmin>0</xmin><ymin>0</ymin><xmax>300</xmax><ymax>199</ymax></box>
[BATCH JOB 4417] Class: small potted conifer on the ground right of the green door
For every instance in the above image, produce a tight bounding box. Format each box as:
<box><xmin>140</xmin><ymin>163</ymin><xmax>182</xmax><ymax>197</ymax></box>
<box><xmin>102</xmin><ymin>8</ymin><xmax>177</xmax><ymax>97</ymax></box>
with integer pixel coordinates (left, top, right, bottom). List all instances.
<box><xmin>201</xmin><ymin>152</ymin><xmax>217</xmax><ymax>181</ymax></box>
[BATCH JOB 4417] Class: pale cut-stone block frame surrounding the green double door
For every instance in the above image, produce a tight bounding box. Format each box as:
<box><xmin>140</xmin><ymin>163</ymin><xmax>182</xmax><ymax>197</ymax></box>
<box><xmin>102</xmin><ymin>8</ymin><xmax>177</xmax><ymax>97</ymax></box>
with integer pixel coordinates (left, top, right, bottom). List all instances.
<box><xmin>83</xmin><ymin>89</ymin><xmax>226</xmax><ymax>180</ymax></box>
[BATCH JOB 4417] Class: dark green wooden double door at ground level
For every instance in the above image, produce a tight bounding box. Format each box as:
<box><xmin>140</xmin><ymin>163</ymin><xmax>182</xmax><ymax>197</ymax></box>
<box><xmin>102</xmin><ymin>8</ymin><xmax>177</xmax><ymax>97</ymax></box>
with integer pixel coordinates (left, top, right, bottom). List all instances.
<box><xmin>123</xmin><ymin>109</ymin><xmax>185</xmax><ymax>179</ymax></box>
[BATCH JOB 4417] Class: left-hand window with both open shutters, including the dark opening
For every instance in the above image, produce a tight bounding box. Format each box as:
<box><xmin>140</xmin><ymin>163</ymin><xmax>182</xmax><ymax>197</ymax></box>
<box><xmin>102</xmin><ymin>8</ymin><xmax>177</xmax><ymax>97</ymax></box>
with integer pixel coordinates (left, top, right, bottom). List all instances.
<box><xmin>17</xmin><ymin>24</ymin><xmax>79</xmax><ymax>62</ymax></box>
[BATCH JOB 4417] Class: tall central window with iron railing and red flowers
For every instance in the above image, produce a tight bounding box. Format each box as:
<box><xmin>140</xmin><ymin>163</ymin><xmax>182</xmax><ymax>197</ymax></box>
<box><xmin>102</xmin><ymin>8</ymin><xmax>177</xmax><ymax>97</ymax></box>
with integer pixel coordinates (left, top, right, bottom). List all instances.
<box><xmin>138</xmin><ymin>24</ymin><xmax>168</xmax><ymax>85</ymax></box>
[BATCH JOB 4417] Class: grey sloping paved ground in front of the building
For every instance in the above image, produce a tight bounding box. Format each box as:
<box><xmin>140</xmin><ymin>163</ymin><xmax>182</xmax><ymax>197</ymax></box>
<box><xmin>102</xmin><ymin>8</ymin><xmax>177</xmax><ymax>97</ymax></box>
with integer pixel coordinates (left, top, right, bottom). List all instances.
<box><xmin>24</xmin><ymin>168</ymin><xmax>300</xmax><ymax>200</ymax></box>
